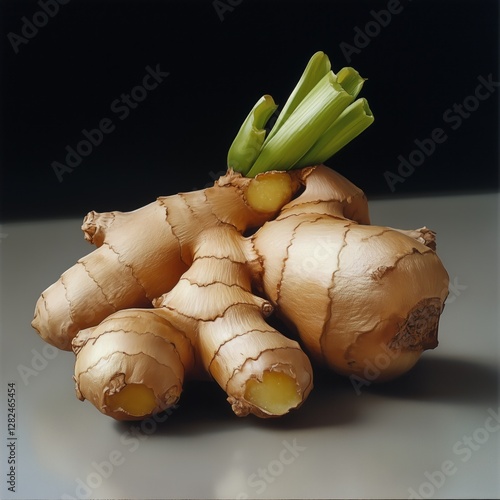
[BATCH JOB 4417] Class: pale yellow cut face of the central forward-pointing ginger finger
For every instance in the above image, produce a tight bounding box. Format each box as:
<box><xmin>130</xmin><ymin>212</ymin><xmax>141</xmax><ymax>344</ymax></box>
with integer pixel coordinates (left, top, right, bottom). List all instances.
<box><xmin>245</xmin><ymin>371</ymin><xmax>302</xmax><ymax>415</ymax></box>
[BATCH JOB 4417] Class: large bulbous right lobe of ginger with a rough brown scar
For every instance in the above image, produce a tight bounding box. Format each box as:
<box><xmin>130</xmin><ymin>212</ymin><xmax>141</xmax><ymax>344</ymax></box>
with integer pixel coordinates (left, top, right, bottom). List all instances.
<box><xmin>253</xmin><ymin>167</ymin><xmax>448</xmax><ymax>381</ymax></box>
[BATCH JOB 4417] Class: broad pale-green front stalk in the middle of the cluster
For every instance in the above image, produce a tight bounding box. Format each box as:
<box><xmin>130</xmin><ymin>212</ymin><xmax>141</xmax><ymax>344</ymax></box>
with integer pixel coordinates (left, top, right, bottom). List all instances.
<box><xmin>246</xmin><ymin>71</ymin><xmax>354</xmax><ymax>177</ymax></box>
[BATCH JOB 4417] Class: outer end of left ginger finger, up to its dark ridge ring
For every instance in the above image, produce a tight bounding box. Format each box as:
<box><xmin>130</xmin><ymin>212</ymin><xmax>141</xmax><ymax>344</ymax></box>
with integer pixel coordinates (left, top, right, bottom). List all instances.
<box><xmin>32</xmin><ymin>202</ymin><xmax>187</xmax><ymax>350</ymax></box>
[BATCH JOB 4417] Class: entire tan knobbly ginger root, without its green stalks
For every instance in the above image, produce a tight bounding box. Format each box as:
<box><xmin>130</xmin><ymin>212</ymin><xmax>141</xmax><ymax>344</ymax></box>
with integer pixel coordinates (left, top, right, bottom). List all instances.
<box><xmin>32</xmin><ymin>165</ymin><xmax>448</xmax><ymax>420</ymax></box>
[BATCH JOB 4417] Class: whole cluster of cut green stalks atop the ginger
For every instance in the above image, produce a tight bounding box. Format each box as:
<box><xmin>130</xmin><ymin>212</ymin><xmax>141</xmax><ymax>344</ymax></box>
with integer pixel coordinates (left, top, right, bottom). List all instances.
<box><xmin>227</xmin><ymin>52</ymin><xmax>374</xmax><ymax>177</ymax></box>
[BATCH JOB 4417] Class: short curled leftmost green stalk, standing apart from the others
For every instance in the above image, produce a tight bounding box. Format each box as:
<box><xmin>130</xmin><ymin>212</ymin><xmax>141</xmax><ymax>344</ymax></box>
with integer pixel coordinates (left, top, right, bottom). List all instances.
<box><xmin>227</xmin><ymin>95</ymin><xmax>278</xmax><ymax>175</ymax></box>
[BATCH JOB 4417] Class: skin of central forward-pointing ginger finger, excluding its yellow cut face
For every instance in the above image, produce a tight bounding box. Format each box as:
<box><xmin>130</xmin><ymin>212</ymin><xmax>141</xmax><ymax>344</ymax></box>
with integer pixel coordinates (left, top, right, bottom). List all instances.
<box><xmin>155</xmin><ymin>226</ymin><xmax>312</xmax><ymax>417</ymax></box>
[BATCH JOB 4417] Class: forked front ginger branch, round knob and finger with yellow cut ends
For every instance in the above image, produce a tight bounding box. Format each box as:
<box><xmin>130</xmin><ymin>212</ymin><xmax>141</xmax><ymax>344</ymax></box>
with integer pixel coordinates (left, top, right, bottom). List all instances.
<box><xmin>73</xmin><ymin>225</ymin><xmax>313</xmax><ymax>419</ymax></box>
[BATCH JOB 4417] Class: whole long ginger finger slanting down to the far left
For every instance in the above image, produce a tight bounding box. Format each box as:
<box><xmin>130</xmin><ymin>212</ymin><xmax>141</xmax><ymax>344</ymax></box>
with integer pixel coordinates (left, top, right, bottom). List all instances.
<box><xmin>32</xmin><ymin>172</ymin><xmax>292</xmax><ymax>350</ymax></box>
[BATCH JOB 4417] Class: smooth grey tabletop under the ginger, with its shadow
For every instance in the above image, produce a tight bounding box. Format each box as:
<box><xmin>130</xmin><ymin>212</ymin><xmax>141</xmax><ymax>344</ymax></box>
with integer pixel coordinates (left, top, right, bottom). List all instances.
<box><xmin>0</xmin><ymin>189</ymin><xmax>500</xmax><ymax>499</ymax></box>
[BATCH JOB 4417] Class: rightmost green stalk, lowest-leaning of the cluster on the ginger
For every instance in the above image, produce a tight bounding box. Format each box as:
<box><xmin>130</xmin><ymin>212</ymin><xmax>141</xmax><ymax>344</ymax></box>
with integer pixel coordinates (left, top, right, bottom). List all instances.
<box><xmin>294</xmin><ymin>98</ymin><xmax>374</xmax><ymax>168</ymax></box>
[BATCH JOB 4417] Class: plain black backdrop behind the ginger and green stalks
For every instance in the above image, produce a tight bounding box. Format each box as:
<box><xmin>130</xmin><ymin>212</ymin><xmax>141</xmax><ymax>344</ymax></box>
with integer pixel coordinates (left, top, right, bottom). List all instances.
<box><xmin>0</xmin><ymin>0</ymin><xmax>500</xmax><ymax>221</ymax></box>
